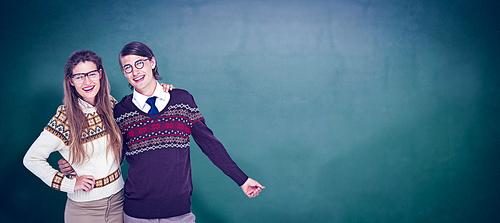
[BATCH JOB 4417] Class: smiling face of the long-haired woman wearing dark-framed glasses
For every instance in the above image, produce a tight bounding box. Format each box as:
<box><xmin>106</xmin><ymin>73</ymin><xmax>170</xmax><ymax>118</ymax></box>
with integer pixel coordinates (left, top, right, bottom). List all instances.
<box><xmin>70</xmin><ymin>61</ymin><xmax>101</xmax><ymax>105</ymax></box>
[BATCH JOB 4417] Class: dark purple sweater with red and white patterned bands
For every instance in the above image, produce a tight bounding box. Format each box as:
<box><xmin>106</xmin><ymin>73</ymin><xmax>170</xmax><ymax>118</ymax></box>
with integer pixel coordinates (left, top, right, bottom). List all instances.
<box><xmin>114</xmin><ymin>89</ymin><xmax>248</xmax><ymax>219</ymax></box>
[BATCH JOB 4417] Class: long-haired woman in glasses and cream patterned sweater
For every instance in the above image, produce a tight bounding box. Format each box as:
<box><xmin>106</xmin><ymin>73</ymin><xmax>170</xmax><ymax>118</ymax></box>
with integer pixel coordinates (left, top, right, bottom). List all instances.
<box><xmin>23</xmin><ymin>50</ymin><xmax>172</xmax><ymax>222</ymax></box>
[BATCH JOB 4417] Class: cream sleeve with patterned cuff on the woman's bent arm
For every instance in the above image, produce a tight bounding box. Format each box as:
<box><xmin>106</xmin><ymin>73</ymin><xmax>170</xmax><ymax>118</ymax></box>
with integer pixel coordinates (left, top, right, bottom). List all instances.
<box><xmin>23</xmin><ymin>129</ymin><xmax>76</xmax><ymax>193</ymax></box>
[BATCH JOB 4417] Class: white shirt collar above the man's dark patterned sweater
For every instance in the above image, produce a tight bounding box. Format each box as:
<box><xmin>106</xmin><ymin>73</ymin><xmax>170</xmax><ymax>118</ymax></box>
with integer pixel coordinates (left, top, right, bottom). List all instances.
<box><xmin>132</xmin><ymin>81</ymin><xmax>170</xmax><ymax>113</ymax></box>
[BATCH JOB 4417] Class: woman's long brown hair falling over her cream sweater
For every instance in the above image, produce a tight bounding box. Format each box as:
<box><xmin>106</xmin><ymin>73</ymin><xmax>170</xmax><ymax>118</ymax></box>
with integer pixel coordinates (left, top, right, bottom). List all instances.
<box><xmin>63</xmin><ymin>50</ymin><xmax>122</xmax><ymax>165</ymax></box>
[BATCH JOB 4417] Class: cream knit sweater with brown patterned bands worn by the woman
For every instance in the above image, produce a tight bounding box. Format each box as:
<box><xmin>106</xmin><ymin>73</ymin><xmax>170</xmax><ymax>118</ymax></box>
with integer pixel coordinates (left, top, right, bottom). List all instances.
<box><xmin>23</xmin><ymin>98</ymin><xmax>124</xmax><ymax>202</ymax></box>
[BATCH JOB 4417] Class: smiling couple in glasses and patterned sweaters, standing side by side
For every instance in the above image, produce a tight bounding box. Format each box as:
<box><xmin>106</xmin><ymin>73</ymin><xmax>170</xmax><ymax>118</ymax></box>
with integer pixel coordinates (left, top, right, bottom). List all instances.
<box><xmin>23</xmin><ymin>42</ymin><xmax>264</xmax><ymax>222</ymax></box>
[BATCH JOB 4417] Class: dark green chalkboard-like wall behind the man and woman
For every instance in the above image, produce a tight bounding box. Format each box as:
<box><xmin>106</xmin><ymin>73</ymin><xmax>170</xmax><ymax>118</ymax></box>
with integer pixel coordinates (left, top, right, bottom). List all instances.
<box><xmin>0</xmin><ymin>0</ymin><xmax>500</xmax><ymax>223</ymax></box>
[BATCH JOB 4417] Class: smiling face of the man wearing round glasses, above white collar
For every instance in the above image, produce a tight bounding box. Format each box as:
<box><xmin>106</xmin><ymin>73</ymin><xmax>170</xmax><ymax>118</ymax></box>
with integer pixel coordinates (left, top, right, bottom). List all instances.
<box><xmin>120</xmin><ymin>55</ymin><xmax>156</xmax><ymax>96</ymax></box>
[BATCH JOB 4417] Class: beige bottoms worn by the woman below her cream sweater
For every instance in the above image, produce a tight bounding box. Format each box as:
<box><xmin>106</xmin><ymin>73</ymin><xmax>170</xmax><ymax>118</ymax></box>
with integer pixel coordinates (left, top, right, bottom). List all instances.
<box><xmin>64</xmin><ymin>190</ymin><xmax>123</xmax><ymax>223</ymax></box>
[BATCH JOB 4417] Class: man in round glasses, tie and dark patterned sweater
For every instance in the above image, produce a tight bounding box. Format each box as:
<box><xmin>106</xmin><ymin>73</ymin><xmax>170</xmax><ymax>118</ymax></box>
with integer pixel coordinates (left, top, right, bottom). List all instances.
<box><xmin>114</xmin><ymin>42</ymin><xmax>264</xmax><ymax>222</ymax></box>
